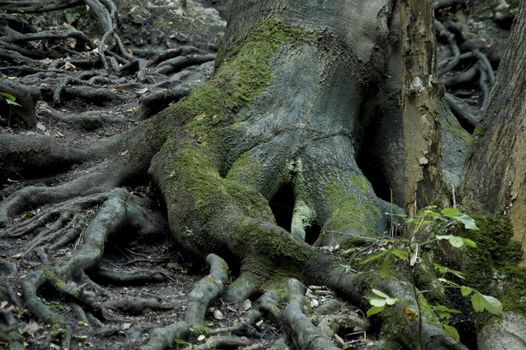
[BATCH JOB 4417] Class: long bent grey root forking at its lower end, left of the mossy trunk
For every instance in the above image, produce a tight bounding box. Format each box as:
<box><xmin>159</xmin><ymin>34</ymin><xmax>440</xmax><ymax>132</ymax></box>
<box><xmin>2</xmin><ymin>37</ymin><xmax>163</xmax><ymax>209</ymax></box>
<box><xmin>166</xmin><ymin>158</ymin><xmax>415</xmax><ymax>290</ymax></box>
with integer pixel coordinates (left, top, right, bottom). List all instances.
<box><xmin>22</xmin><ymin>188</ymin><xmax>161</xmax><ymax>343</ymax></box>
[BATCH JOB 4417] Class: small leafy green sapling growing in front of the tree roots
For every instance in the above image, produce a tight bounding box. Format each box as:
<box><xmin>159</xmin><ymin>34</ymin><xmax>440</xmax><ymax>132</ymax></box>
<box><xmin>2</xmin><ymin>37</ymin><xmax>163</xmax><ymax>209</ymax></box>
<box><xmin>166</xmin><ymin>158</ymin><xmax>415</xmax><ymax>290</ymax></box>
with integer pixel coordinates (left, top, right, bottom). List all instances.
<box><xmin>361</xmin><ymin>207</ymin><xmax>502</xmax><ymax>340</ymax></box>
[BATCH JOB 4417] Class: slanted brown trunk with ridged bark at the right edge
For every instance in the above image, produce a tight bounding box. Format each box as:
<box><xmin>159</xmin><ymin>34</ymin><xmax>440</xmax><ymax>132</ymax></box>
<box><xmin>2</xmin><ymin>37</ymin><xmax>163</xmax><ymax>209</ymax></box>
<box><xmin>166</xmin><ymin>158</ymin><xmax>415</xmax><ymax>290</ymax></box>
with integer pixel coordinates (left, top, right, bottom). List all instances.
<box><xmin>462</xmin><ymin>1</ymin><xmax>526</xmax><ymax>262</ymax></box>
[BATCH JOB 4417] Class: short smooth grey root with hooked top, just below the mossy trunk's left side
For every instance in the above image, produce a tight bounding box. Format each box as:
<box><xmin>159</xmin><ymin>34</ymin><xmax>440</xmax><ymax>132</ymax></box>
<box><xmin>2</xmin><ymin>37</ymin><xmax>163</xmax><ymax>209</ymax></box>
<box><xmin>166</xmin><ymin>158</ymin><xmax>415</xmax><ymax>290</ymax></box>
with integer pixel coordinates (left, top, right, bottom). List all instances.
<box><xmin>185</xmin><ymin>254</ymin><xmax>229</xmax><ymax>325</ymax></box>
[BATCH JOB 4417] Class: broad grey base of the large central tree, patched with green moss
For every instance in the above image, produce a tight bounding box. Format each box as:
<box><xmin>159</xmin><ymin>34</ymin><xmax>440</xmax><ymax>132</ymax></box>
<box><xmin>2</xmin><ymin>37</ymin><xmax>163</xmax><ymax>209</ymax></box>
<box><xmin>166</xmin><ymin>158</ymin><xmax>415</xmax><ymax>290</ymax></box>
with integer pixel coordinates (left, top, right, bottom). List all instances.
<box><xmin>141</xmin><ymin>0</ymin><xmax>460</xmax><ymax>349</ymax></box>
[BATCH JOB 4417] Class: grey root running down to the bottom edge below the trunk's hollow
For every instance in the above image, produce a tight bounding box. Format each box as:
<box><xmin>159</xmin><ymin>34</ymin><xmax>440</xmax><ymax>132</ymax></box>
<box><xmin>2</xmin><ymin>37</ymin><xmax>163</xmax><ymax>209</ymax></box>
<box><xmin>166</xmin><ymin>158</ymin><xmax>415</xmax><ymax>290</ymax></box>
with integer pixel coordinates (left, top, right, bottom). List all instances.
<box><xmin>283</xmin><ymin>279</ymin><xmax>338</xmax><ymax>350</ymax></box>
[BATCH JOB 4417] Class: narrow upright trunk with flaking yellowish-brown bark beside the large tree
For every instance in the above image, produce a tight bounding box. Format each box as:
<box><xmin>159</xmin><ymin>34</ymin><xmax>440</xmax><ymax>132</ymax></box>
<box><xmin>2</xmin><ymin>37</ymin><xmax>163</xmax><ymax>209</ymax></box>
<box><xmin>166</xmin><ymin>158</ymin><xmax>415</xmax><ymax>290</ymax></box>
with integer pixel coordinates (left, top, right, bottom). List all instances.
<box><xmin>399</xmin><ymin>0</ymin><xmax>442</xmax><ymax>214</ymax></box>
